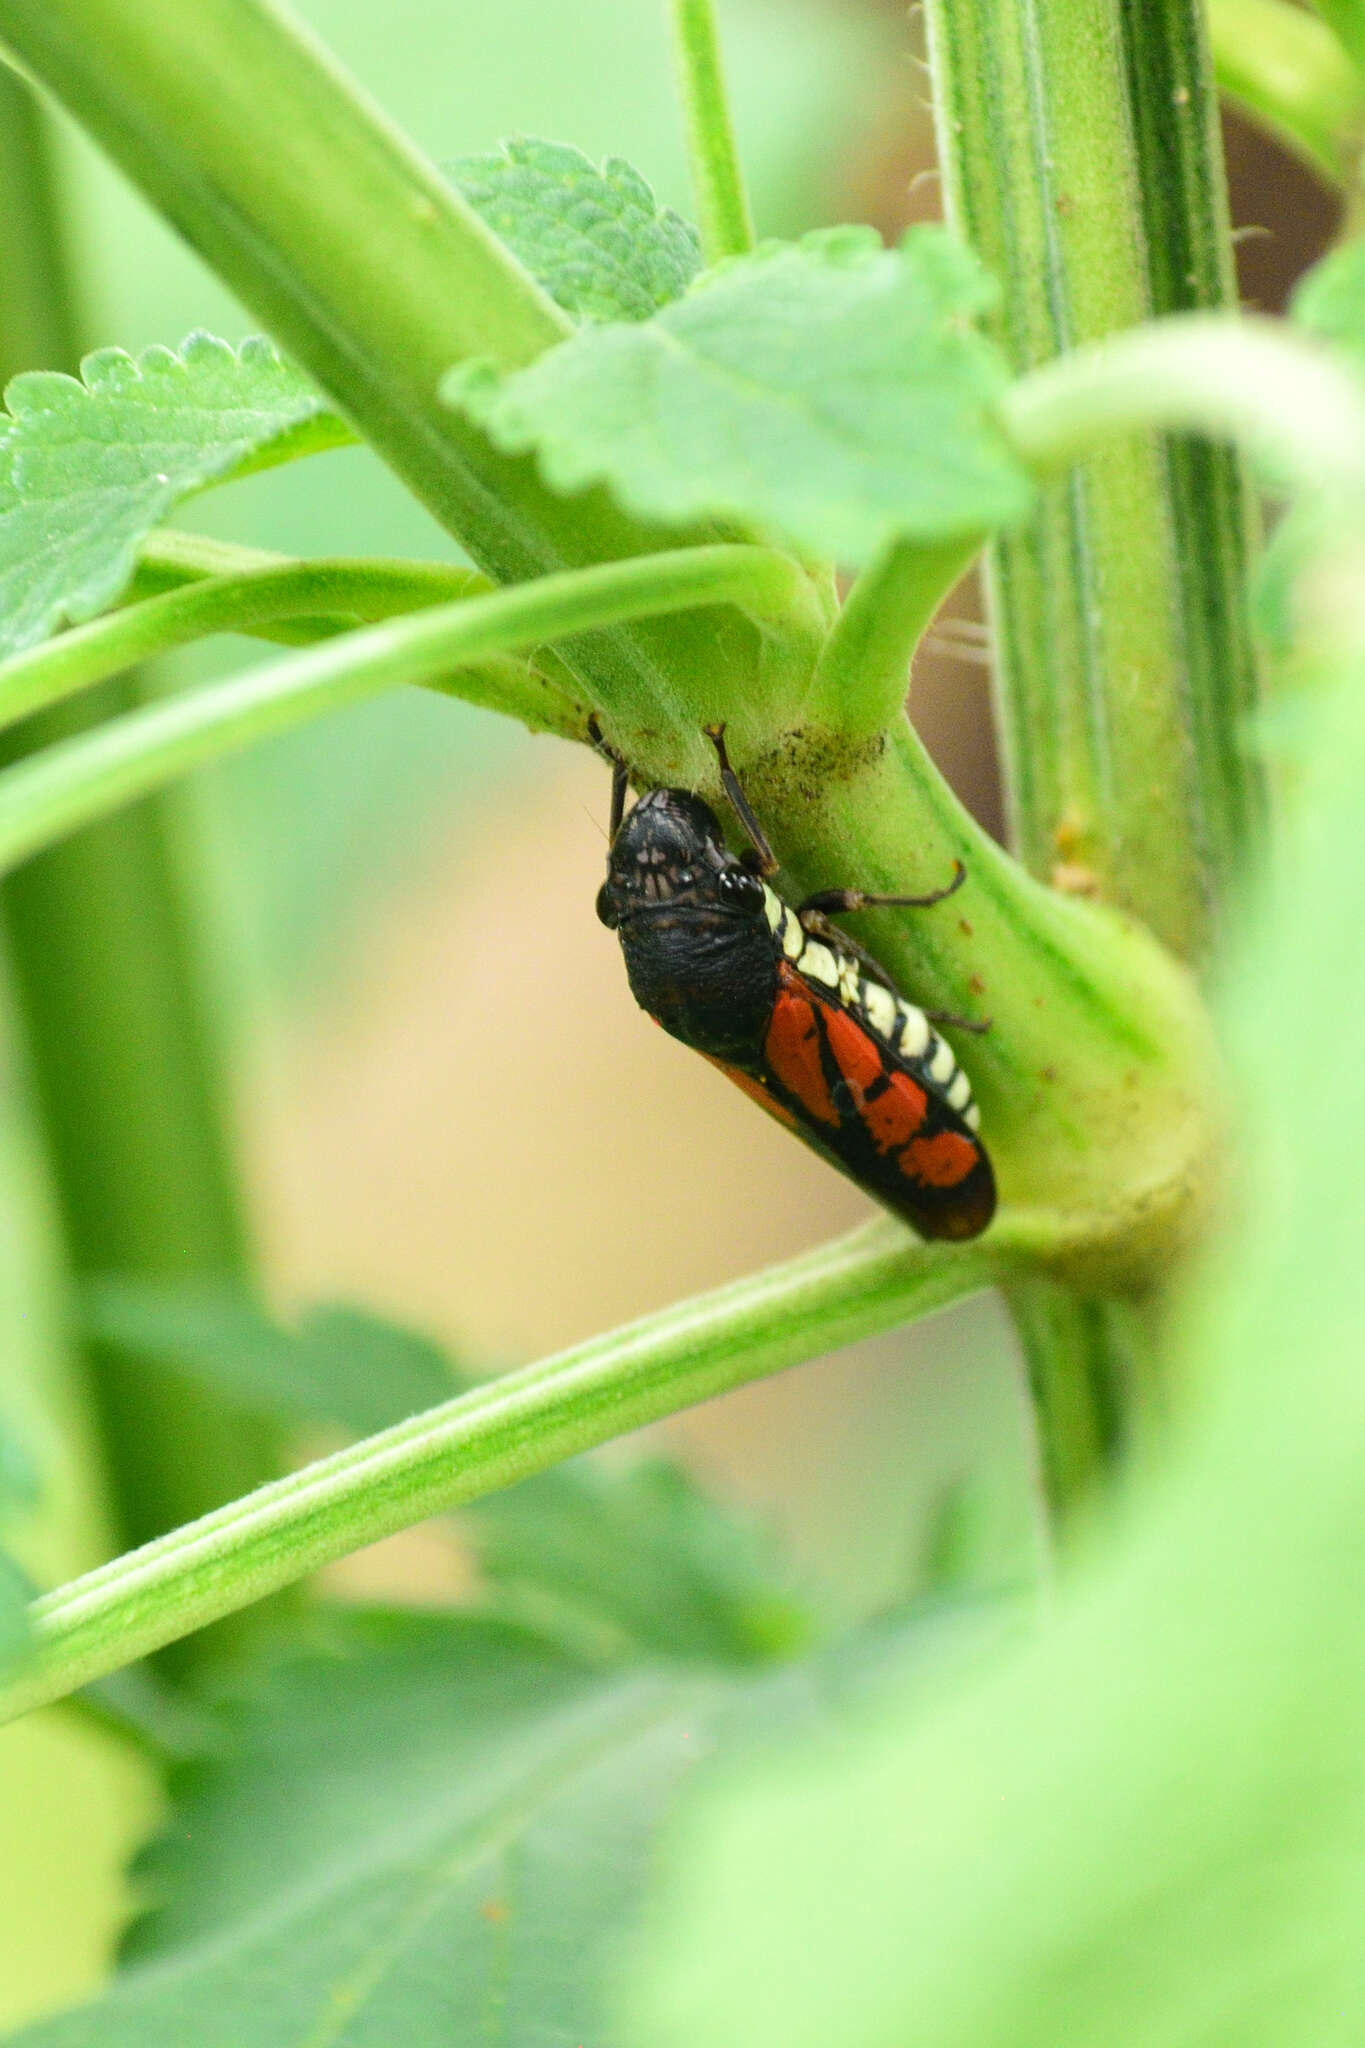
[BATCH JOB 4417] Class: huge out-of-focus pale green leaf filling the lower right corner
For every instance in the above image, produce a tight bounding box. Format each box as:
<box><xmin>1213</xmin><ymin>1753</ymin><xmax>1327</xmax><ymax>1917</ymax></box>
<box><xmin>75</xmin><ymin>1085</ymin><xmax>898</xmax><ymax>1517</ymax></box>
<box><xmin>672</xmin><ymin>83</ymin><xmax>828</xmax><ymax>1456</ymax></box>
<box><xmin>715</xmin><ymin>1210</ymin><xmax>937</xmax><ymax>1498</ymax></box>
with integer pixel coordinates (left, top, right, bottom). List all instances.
<box><xmin>626</xmin><ymin>530</ymin><xmax>1365</xmax><ymax>2048</ymax></box>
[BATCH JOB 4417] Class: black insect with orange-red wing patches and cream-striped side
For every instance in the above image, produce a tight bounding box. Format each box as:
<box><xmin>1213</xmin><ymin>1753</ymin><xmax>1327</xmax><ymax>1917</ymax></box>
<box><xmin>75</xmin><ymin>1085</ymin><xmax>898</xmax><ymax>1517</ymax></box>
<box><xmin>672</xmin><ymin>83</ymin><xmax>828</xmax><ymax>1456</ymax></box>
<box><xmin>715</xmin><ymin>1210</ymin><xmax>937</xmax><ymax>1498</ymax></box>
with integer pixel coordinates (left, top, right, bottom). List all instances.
<box><xmin>598</xmin><ymin>727</ymin><xmax>995</xmax><ymax>1239</ymax></box>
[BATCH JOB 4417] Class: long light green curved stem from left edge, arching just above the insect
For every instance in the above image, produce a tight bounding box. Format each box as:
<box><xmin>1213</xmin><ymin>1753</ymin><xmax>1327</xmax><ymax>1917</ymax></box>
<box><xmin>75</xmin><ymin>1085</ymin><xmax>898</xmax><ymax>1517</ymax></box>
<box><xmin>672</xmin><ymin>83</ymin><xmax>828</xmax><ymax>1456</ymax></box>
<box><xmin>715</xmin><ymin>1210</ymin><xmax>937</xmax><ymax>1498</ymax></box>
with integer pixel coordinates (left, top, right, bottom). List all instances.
<box><xmin>0</xmin><ymin>547</ymin><xmax>800</xmax><ymax>870</ymax></box>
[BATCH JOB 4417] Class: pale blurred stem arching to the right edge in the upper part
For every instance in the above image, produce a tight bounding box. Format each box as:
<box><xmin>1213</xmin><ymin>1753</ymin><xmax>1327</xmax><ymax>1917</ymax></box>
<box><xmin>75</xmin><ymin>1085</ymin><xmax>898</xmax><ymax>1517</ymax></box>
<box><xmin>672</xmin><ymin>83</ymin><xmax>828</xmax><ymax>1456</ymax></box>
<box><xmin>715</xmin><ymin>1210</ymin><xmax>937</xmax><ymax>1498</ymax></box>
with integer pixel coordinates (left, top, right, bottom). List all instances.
<box><xmin>1005</xmin><ymin>313</ymin><xmax>1365</xmax><ymax>492</ymax></box>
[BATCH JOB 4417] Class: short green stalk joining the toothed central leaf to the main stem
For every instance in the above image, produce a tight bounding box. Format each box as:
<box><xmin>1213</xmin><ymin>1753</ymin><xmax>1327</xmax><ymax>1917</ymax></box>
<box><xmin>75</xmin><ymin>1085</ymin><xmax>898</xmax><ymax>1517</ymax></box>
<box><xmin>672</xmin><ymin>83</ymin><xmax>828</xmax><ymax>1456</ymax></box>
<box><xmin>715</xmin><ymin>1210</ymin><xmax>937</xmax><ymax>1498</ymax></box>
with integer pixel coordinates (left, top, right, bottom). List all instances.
<box><xmin>802</xmin><ymin>541</ymin><xmax>980</xmax><ymax>743</ymax></box>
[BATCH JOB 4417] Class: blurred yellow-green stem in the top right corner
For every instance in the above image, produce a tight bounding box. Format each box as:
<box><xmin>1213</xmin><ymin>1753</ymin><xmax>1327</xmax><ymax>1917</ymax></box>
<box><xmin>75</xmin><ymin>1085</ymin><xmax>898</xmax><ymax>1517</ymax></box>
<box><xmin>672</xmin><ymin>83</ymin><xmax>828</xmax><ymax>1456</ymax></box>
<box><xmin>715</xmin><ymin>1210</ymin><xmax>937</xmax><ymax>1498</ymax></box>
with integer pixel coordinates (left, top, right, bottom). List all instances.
<box><xmin>1209</xmin><ymin>0</ymin><xmax>1365</xmax><ymax>190</ymax></box>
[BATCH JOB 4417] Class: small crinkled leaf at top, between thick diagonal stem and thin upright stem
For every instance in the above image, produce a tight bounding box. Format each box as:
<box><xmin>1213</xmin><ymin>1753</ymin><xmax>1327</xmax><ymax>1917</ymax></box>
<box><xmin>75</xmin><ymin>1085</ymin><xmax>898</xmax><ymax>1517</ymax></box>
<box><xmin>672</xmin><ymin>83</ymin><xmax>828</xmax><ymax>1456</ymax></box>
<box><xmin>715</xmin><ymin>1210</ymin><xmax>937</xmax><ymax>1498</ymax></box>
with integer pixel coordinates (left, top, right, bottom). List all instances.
<box><xmin>446</xmin><ymin>137</ymin><xmax>702</xmax><ymax>319</ymax></box>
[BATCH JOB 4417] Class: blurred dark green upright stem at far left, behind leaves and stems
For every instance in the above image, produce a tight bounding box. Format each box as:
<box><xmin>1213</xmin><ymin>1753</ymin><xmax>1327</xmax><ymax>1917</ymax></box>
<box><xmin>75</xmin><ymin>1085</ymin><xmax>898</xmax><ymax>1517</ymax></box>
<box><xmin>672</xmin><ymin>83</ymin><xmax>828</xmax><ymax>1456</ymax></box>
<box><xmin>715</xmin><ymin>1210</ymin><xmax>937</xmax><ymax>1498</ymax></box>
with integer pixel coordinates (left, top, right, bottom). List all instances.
<box><xmin>0</xmin><ymin>68</ymin><xmax>274</xmax><ymax>1542</ymax></box>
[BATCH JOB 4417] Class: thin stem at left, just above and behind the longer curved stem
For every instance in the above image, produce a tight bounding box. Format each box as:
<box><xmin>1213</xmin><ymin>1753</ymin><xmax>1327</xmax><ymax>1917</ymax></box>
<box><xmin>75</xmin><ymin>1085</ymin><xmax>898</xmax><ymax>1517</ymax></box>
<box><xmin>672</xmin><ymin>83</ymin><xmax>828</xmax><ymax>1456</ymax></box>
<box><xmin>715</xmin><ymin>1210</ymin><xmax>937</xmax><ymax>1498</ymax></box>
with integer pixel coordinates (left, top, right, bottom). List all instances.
<box><xmin>0</xmin><ymin>559</ymin><xmax>568</xmax><ymax>737</ymax></box>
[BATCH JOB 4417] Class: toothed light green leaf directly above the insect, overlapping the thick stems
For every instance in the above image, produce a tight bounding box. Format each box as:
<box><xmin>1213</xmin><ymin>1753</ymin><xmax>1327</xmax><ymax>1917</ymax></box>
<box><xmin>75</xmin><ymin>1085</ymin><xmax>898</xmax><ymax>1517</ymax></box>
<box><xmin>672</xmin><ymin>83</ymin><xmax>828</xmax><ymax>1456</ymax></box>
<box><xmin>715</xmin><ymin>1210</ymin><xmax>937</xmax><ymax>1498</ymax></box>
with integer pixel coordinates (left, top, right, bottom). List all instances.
<box><xmin>444</xmin><ymin>227</ymin><xmax>1029</xmax><ymax>563</ymax></box>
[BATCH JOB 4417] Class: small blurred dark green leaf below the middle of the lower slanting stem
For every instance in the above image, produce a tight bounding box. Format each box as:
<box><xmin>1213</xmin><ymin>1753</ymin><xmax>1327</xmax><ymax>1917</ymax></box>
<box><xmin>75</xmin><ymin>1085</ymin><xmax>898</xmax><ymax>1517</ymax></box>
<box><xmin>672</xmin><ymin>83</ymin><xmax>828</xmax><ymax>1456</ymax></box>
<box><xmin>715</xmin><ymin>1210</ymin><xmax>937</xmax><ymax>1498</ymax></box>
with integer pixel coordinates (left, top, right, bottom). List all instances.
<box><xmin>465</xmin><ymin>1458</ymin><xmax>812</xmax><ymax>1663</ymax></box>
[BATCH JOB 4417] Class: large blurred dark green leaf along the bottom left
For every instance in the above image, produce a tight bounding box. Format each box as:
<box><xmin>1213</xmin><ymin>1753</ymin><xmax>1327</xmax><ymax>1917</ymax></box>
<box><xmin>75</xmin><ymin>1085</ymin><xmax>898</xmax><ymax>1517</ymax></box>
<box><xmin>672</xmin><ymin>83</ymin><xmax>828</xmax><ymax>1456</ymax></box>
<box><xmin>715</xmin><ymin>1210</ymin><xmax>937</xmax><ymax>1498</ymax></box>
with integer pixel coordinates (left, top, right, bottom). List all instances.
<box><xmin>18</xmin><ymin>1610</ymin><xmax>1015</xmax><ymax>2048</ymax></box>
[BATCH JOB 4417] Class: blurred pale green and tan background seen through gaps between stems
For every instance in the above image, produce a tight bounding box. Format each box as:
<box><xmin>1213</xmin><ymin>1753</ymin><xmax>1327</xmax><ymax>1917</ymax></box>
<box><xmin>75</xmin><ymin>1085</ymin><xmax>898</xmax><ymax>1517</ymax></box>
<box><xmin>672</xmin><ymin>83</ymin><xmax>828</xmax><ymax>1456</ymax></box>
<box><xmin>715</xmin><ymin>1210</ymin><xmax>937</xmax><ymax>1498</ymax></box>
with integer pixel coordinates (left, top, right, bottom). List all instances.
<box><xmin>0</xmin><ymin>0</ymin><xmax>1326</xmax><ymax>2025</ymax></box>
